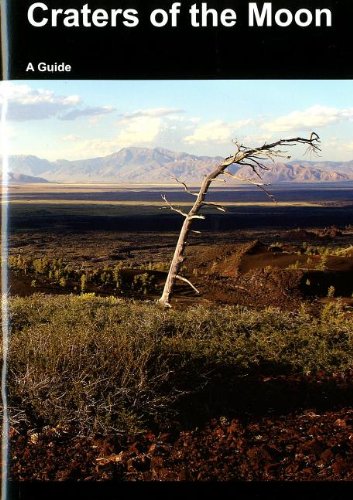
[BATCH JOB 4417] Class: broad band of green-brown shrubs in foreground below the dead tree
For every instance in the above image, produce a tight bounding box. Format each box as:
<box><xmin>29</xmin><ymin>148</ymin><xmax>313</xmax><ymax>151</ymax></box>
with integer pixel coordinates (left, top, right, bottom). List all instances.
<box><xmin>4</xmin><ymin>294</ymin><xmax>353</xmax><ymax>433</ymax></box>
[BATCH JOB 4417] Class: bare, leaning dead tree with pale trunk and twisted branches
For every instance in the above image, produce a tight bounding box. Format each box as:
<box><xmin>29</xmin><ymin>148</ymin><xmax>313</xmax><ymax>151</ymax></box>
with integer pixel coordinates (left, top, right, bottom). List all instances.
<box><xmin>158</xmin><ymin>132</ymin><xmax>320</xmax><ymax>307</ymax></box>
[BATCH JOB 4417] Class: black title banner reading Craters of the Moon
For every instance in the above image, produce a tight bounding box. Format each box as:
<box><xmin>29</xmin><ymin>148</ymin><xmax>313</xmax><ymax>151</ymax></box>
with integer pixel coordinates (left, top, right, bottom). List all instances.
<box><xmin>5</xmin><ymin>0</ymin><xmax>353</xmax><ymax>79</ymax></box>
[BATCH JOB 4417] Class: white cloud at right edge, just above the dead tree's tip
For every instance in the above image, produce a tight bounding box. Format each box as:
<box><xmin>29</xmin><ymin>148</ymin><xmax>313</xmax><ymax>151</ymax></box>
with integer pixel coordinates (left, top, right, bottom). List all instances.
<box><xmin>261</xmin><ymin>105</ymin><xmax>353</xmax><ymax>132</ymax></box>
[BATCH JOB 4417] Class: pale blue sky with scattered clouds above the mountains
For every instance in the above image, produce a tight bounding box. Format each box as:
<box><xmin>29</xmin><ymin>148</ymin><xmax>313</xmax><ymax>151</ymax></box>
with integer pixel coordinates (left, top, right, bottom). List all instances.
<box><xmin>0</xmin><ymin>80</ymin><xmax>353</xmax><ymax>161</ymax></box>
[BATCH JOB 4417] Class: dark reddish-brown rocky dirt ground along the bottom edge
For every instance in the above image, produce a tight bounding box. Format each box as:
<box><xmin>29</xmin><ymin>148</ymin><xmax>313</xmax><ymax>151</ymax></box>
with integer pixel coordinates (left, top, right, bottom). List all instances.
<box><xmin>11</xmin><ymin>373</ymin><xmax>353</xmax><ymax>481</ymax></box>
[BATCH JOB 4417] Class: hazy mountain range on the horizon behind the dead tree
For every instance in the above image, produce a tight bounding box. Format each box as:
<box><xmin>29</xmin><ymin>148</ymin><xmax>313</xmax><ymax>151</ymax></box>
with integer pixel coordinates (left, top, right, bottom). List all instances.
<box><xmin>9</xmin><ymin>147</ymin><xmax>353</xmax><ymax>184</ymax></box>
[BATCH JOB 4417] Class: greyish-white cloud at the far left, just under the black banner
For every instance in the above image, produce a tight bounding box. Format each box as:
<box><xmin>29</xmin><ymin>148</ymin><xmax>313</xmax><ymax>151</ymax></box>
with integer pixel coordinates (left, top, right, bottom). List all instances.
<box><xmin>0</xmin><ymin>82</ymin><xmax>114</xmax><ymax>122</ymax></box>
